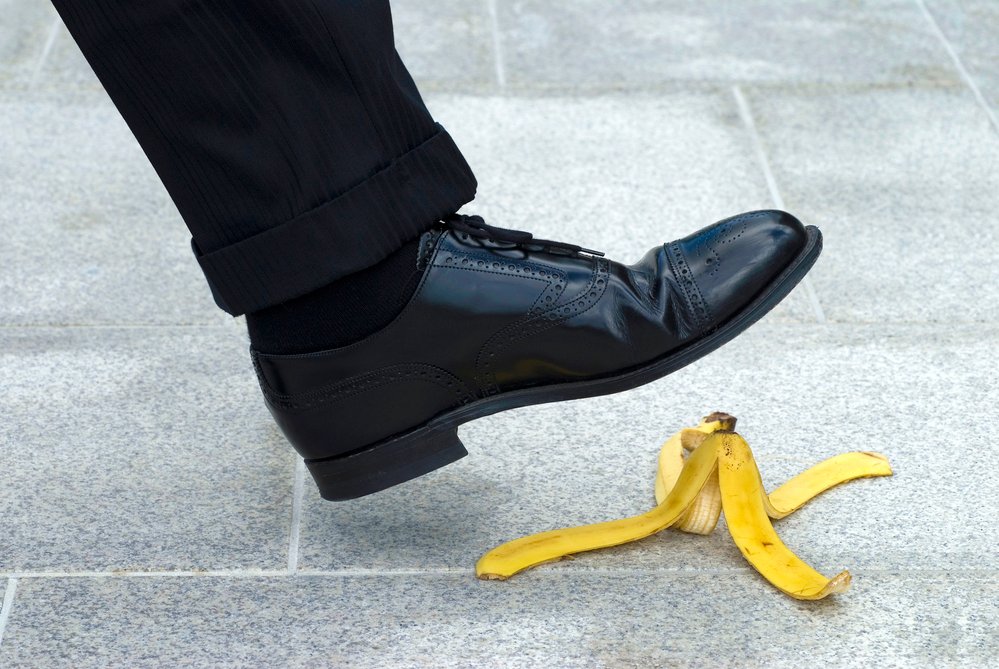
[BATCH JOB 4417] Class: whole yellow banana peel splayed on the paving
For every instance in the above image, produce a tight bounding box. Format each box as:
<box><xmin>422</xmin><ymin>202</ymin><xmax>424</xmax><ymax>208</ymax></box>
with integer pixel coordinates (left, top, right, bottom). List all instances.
<box><xmin>476</xmin><ymin>413</ymin><xmax>892</xmax><ymax>599</ymax></box>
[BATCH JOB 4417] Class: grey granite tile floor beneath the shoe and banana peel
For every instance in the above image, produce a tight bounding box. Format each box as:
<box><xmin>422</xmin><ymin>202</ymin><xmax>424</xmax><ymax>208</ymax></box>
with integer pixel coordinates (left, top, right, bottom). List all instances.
<box><xmin>0</xmin><ymin>0</ymin><xmax>999</xmax><ymax>668</ymax></box>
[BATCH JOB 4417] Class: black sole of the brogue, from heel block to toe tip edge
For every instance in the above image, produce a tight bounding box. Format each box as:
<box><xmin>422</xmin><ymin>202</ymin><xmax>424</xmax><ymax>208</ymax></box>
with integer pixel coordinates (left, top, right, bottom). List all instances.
<box><xmin>305</xmin><ymin>226</ymin><xmax>822</xmax><ymax>501</ymax></box>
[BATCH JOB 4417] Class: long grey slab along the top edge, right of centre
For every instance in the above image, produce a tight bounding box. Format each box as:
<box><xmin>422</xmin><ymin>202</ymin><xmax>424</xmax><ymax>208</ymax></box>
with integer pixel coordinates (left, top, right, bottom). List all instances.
<box><xmin>497</xmin><ymin>0</ymin><xmax>958</xmax><ymax>90</ymax></box>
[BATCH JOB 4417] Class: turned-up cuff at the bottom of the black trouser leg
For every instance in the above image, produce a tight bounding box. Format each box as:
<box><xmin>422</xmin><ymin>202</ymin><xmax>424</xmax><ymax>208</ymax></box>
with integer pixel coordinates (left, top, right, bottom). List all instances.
<box><xmin>191</xmin><ymin>125</ymin><xmax>476</xmax><ymax>316</ymax></box>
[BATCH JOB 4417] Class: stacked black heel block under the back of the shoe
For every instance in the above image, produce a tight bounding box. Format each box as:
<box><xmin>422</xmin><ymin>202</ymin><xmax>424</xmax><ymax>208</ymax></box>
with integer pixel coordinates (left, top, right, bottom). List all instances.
<box><xmin>305</xmin><ymin>427</ymin><xmax>468</xmax><ymax>501</ymax></box>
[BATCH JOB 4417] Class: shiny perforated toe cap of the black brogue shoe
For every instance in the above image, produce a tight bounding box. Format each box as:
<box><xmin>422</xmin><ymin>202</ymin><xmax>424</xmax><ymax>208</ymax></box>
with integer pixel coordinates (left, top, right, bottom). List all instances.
<box><xmin>674</xmin><ymin>210</ymin><xmax>807</xmax><ymax>328</ymax></box>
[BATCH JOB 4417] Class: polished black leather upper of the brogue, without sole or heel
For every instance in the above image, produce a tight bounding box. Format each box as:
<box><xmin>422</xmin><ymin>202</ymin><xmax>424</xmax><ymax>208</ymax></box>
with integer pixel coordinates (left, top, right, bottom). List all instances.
<box><xmin>252</xmin><ymin>211</ymin><xmax>806</xmax><ymax>459</ymax></box>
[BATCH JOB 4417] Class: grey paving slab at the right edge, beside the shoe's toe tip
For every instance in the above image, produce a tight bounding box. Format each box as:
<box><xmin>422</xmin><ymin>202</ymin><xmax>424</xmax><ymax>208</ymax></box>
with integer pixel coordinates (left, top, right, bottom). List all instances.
<box><xmin>747</xmin><ymin>89</ymin><xmax>999</xmax><ymax>323</ymax></box>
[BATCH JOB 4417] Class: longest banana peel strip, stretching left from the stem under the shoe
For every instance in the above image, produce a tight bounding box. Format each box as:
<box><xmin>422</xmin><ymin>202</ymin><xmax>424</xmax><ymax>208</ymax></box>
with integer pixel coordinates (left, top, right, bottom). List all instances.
<box><xmin>475</xmin><ymin>434</ymin><xmax>720</xmax><ymax>580</ymax></box>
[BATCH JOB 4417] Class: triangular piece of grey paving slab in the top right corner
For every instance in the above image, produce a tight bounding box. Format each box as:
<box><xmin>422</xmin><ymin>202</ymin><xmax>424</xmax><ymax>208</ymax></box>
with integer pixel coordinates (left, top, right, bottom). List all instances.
<box><xmin>923</xmin><ymin>0</ymin><xmax>999</xmax><ymax>114</ymax></box>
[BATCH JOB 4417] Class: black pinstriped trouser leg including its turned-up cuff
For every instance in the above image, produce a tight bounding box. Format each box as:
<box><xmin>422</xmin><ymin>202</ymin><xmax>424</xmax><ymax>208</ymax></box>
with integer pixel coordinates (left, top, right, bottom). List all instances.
<box><xmin>53</xmin><ymin>0</ymin><xmax>476</xmax><ymax>314</ymax></box>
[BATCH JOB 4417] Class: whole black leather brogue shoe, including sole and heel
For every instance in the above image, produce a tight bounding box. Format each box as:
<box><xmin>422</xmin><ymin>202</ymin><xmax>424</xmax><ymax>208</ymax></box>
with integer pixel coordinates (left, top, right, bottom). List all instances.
<box><xmin>251</xmin><ymin>211</ymin><xmax>822</xmax><ymax>500</ymax></box>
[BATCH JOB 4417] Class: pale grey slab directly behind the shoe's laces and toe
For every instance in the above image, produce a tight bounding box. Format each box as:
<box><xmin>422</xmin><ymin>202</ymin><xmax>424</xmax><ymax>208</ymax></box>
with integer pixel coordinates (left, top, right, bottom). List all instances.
<box><xmin>429</xmin><ymin>89</ymin><xmax>814</xmax><ymax>322</ymax></box>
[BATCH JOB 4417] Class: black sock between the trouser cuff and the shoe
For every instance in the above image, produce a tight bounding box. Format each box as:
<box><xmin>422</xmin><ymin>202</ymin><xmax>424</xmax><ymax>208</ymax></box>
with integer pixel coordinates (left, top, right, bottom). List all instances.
<box><xmin>246</xmin><ymin>237</ymin><xmax>423</xmax><ymax>354</ymax></box>
